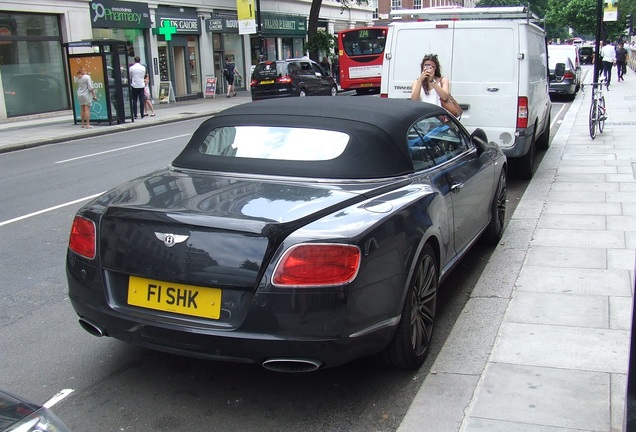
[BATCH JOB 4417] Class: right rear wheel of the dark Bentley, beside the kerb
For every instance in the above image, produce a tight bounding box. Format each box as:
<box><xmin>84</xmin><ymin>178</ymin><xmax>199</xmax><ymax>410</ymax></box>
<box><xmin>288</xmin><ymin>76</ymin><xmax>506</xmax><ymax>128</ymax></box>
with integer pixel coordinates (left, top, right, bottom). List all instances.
<box><xmin>375</xmin><ymin>244</ymin><xmax>439</xmax><ymax>370</ymax></box>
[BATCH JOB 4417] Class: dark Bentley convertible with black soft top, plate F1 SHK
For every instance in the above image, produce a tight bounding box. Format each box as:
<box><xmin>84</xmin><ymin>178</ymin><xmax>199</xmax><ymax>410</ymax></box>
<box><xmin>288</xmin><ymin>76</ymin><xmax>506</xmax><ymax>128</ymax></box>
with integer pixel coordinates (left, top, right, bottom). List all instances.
<box><xmin>66</xmin><ymin>97</ymin><xmax>507</xmax><ymax>372</ymax></box>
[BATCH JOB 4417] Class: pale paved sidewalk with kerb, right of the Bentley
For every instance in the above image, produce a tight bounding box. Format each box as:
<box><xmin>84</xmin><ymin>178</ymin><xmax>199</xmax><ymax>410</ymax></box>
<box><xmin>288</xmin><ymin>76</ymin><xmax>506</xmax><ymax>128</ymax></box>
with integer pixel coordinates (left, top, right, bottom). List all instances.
<box><xmin>398</xmin><ymin>69</ymin><xmax>636</xmax><ymax>432</ymax></box>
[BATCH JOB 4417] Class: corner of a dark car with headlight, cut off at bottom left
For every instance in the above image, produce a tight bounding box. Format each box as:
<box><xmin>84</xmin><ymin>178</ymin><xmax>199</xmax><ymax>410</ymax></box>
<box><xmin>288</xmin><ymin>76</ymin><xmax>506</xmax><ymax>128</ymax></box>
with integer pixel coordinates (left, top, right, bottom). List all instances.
<box><xmin>0</xmin><ymin>390</ymin><xmax>69</xmax><ymax>432</ymax></box>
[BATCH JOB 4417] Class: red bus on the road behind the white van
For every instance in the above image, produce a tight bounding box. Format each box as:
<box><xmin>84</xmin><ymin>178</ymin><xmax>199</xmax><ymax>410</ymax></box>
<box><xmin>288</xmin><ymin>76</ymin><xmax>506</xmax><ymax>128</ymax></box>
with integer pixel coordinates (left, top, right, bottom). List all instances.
<box><xmin>338</xmin><ymin>27</ymin><xmax>389</xmax><ymax>93</ymax></box>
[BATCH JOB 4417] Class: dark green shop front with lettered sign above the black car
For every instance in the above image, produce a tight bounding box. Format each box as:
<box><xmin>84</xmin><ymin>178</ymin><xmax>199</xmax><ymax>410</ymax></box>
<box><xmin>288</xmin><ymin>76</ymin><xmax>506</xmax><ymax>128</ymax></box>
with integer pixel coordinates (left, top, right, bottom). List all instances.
<box><xmin>250</xmin><ymin>12</ymin><xmax>307</xmax><ymax>64</ymax></box>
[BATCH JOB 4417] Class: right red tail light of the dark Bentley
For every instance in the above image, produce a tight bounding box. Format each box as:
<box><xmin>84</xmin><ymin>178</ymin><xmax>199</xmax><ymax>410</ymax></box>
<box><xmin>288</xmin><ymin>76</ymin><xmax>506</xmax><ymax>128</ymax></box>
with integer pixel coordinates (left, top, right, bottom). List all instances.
<box><xmin>272</xmin><ymin>243</ymin><xmax>361</xmax><ymax>287</ymax></box>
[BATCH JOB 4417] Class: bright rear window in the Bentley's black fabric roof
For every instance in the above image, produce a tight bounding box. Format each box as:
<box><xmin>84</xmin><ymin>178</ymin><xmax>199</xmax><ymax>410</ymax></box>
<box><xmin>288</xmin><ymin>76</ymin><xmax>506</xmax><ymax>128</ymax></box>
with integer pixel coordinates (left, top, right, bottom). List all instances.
<box><xmin>199</xmin><ymin>126</ymin><xmax>349</xmax><ymax>161</ymax></box>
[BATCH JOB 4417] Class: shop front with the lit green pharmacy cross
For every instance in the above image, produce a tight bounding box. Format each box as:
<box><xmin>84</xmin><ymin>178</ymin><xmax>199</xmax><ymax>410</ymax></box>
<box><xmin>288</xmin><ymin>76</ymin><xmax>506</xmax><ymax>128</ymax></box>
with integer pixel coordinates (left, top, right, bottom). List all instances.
<box><xmin>153</xmin><ymin>7</ymin><xmax>204</xmax><ymax>101</ymax></box>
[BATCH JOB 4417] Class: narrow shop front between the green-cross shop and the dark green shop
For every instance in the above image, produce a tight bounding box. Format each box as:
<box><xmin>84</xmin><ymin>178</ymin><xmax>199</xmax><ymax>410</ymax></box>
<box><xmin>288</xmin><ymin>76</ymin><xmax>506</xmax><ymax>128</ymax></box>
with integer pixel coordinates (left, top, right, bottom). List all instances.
<box><xmin>205</xmin><ymin>11</ymin><xmax>249</xmax><ymax>94</ymax></box>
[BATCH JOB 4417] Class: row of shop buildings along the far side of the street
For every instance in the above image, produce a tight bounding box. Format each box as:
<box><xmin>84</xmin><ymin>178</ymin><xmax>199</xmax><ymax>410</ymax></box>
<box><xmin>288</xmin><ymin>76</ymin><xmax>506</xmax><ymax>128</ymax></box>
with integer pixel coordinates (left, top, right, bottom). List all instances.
<box><xmin>0</xmin><ymin>0</ymin><xmax>374</xmax><ymax>121</ymax></box>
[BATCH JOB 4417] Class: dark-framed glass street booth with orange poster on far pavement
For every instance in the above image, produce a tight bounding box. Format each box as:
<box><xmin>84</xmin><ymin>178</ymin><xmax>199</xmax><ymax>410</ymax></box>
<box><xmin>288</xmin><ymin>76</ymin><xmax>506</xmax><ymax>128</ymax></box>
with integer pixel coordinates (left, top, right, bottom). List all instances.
<box><xmin>64</xmin><ymin>39</ymin><xmax>134</xmax><ymax>124</ymax></box>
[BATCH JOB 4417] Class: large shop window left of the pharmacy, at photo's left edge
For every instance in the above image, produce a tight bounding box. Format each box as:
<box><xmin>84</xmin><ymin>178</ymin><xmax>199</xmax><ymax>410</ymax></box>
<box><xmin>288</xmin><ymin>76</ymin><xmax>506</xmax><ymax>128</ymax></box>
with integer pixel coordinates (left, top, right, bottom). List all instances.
<box><xmin>0</xmin><ymin>11</ymin><xmax>69</xmax><ymax>118</ymax></box>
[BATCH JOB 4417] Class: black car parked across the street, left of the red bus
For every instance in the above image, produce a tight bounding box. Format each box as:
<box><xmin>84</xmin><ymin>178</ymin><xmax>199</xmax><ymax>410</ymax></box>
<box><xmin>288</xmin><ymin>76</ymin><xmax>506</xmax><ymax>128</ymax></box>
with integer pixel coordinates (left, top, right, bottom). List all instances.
<box><xmin>250</xmin><ymin>59</ymin><xmax>338</xmax><ymax>100</ymax></box>
